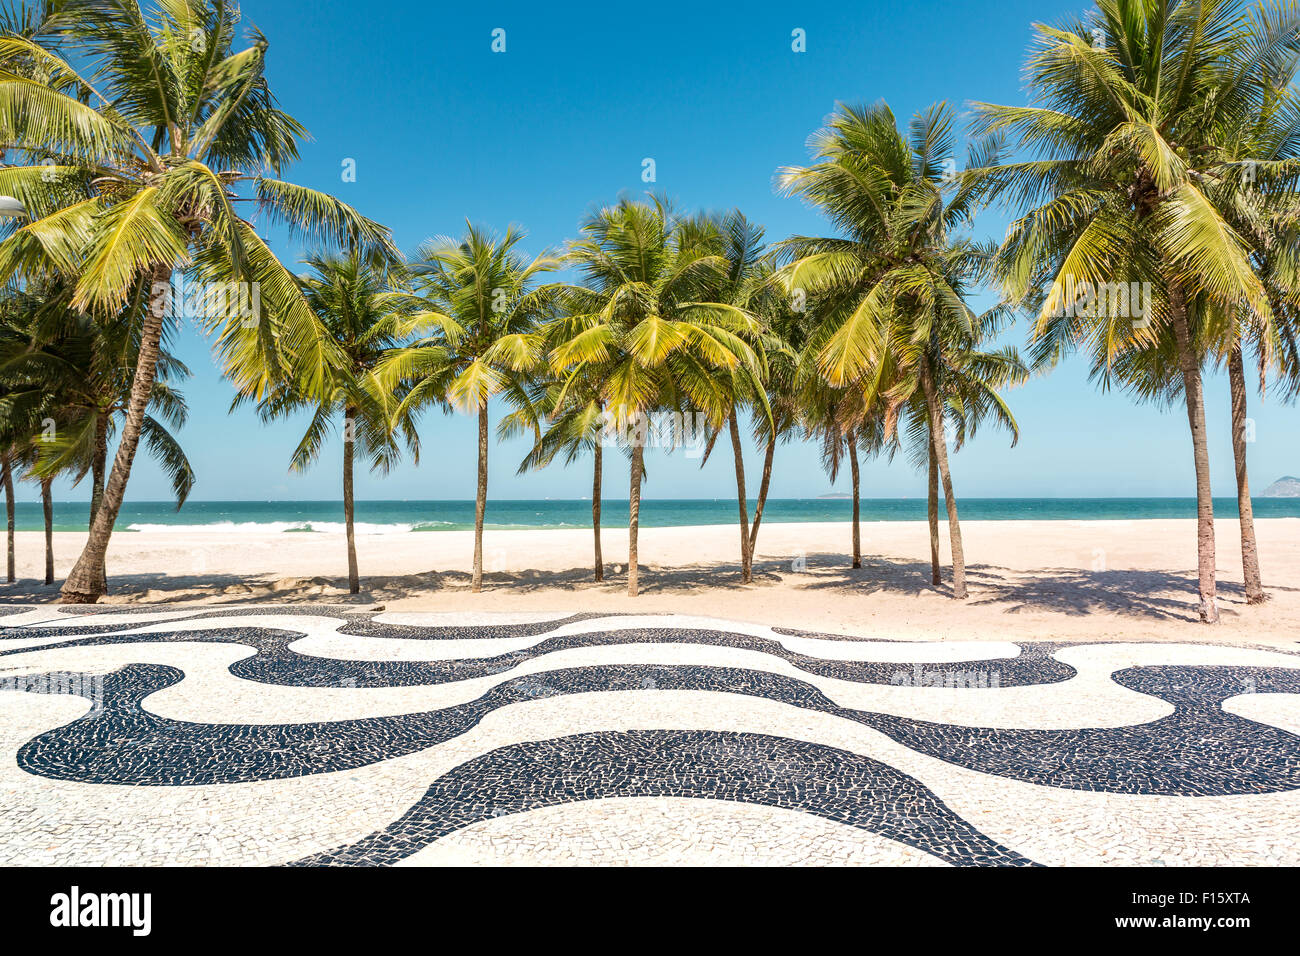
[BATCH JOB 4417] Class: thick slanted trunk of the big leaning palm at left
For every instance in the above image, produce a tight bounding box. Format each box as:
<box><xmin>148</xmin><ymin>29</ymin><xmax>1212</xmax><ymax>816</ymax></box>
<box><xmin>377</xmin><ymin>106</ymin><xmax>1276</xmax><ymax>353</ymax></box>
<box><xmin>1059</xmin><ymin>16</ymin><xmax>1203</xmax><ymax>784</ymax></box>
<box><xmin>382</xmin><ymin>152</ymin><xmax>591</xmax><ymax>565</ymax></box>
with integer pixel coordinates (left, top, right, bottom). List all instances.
<box><xmin>62</xmin><ymin>265</ymin><xmax>172</xmax><ymax>604</ymax></box>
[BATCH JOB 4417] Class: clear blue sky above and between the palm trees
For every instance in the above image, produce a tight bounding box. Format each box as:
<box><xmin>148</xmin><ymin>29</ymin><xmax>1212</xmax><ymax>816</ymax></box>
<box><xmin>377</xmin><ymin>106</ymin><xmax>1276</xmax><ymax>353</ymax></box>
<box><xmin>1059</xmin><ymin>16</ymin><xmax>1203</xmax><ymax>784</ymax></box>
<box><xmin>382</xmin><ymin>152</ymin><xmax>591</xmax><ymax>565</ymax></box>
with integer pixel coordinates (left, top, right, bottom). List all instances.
<box><xmin>22</xmin><ymin>0</ymin><xmax>1300</xmax><ymax>501</ymax></box>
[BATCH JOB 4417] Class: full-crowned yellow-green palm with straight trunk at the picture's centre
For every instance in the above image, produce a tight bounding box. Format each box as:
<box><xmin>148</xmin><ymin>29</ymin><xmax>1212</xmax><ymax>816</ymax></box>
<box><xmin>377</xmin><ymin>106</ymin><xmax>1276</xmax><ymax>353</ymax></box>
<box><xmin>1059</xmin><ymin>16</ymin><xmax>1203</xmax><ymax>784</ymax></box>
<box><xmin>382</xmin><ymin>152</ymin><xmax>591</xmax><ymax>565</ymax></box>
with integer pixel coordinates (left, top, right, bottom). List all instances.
<box><xmin>550</xmin><ymin>196</ymin><xmax>761</xmax><ymax>597</ymax></box>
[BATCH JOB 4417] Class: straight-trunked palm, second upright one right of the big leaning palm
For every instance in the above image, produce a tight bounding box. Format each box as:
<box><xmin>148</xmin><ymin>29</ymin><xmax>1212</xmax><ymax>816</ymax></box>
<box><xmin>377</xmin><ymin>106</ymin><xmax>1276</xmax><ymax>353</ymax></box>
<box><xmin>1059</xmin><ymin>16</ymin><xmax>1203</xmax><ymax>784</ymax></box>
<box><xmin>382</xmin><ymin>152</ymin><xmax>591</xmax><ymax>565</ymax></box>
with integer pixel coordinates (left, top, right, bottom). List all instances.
<box><xmin>381</xmin><ymin>222</ymin><xmax>559</xmax><ymax>593</ymax></box>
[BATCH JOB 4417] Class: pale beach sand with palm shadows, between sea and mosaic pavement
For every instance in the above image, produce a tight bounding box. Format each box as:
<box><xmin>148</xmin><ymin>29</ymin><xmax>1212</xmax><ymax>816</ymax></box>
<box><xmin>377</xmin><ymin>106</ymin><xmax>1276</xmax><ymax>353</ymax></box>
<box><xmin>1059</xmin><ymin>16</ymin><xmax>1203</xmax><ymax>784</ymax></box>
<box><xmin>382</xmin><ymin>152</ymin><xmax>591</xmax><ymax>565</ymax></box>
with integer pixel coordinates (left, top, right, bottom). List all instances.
<box><xmin>0</xmin><ymin>518</ymin><xmax>1300</xmax><ymax>649</ymax></box>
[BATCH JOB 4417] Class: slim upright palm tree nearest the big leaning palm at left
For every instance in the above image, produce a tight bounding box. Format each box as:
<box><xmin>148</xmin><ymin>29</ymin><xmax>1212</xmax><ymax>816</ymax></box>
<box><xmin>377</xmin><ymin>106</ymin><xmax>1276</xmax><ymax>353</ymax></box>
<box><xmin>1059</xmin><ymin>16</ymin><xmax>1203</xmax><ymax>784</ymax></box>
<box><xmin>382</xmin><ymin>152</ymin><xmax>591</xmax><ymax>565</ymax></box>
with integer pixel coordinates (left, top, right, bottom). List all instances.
<box><xmin>245</xmin><ymin>250</ymin><xmax>419</xmax><ymax>594</ymax></box>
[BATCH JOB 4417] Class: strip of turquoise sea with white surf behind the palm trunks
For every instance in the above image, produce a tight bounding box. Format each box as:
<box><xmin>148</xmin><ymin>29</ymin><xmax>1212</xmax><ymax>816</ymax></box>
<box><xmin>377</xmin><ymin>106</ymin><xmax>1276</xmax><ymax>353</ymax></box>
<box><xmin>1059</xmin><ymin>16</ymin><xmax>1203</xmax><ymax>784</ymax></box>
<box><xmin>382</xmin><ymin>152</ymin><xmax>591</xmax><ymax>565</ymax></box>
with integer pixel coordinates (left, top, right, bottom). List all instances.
<box><xmin>17</xmin><ymin>498</ymin><xmax>1300</xmax><ymax>535</ymax></box>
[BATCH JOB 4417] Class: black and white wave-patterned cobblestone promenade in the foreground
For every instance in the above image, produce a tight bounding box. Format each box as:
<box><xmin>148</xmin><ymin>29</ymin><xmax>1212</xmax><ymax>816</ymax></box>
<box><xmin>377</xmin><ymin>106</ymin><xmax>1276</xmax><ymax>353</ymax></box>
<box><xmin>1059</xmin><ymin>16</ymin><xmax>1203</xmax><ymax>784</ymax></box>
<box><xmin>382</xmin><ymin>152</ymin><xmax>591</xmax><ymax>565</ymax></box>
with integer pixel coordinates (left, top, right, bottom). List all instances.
<box><xmin>0</xmin><ymin>605</ymin><xmax>1300</xmax><ymax>866</ymax></box>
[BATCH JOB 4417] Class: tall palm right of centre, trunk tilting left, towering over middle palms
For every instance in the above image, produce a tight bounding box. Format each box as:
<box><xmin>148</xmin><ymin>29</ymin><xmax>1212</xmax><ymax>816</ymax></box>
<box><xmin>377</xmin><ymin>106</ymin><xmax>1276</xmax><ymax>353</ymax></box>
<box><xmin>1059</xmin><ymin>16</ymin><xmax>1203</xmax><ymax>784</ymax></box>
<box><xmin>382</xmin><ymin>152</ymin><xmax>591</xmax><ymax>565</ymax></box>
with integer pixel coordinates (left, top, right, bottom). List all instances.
<box><xmin>777</xmin><ymin>104</ymin><xmax>987</xmax><ymax>600</ymax></box>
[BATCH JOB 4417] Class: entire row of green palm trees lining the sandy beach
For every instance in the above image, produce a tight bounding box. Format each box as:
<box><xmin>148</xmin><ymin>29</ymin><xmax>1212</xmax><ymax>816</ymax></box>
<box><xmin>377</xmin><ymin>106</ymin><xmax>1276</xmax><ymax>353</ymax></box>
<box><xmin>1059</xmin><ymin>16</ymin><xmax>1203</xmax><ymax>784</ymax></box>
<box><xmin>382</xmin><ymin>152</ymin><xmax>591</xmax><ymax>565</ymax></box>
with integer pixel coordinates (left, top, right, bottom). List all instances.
<box><xmin>0</xmin><ymin>0</ymin><xmax>1300</xmax><ymax>622</ymax></box>
